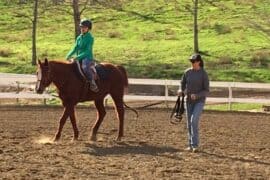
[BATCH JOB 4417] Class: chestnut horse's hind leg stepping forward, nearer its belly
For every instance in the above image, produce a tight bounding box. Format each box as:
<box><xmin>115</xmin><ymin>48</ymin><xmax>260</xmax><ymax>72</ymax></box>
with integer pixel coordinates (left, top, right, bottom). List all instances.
<box><xmin>90</xmin><ymin>99</ymin><xmax>106</xmax><ymax>141</ymax></box>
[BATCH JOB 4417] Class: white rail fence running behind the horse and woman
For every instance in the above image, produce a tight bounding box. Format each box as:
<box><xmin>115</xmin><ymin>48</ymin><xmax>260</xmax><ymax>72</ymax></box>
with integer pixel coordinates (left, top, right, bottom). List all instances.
<box><xmin>0</xmin><ymin>73</ymin><xmax>270</xmax><ymax>105</ymax></box>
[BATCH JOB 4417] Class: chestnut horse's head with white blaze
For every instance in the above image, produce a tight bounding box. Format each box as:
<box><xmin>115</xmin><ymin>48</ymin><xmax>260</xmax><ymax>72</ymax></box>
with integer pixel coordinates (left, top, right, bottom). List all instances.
<box><xmin>36</xmin><ymin>58</ymin><xmax>52</xmax><ymax>94</ymax></box>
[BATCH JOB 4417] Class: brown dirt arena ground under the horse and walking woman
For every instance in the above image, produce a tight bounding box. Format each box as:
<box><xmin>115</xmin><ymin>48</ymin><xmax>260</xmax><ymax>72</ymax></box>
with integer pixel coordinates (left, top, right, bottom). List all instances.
<box><xmin>0</xmin><ymin>106</ymin><xmax>270</xmax><ymax>180</ymax></box>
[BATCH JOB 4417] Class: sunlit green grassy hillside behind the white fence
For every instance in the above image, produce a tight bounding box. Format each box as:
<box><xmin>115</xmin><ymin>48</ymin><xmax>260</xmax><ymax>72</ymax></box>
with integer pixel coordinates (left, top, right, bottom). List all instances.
<box><xmin>0</xmin><ymin>0</ymin><xmax>270</xmax><ymax>82</ymax></box>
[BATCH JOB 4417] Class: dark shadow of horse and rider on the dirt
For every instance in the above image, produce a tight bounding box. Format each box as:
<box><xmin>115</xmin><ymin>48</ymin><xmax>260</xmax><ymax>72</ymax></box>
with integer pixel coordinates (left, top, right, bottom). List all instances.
<box><xmin>84</xmin><ymin>141</ymin><xmax>181</xmax><ymax>159</ymax></box>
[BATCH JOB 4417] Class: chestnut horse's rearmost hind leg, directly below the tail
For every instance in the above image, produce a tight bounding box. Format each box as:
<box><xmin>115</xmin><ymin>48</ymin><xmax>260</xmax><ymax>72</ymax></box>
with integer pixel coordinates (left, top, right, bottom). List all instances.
<box><xmin>111</xmin><ymin>93</ymin><xmax>125</xmax><ymax>141</ymax></box>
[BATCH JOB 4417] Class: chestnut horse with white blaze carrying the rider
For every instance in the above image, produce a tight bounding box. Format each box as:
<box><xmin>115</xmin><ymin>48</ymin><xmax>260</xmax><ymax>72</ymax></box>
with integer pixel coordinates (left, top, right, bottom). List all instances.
<box><xmin>36</xmin><ymin>58</ymin><xmax>132</xmax><ymax>141</ymax></box>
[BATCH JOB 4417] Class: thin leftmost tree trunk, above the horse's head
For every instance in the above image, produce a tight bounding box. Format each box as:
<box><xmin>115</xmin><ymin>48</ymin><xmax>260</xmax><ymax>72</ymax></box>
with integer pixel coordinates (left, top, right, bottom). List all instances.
<box><xmin>32</xmin><ymin>0</ymin><xmax>38</xmax><ymax>65</ymax></box>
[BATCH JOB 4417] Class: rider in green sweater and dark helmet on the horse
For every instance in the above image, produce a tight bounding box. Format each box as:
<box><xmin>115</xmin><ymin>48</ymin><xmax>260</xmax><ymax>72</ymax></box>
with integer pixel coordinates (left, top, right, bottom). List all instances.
<box><xmin>66</xmin><ymin>19</ymin><xmax>99</xmax><ymax>92</ymax></box>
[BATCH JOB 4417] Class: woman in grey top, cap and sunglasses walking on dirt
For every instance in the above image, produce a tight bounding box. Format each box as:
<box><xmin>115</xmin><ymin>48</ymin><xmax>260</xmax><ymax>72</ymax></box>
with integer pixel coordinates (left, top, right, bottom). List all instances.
<box><xmin>178</xmin><ymin>54</ymin><xmax>209</xmax><ymax>152</ymax></box>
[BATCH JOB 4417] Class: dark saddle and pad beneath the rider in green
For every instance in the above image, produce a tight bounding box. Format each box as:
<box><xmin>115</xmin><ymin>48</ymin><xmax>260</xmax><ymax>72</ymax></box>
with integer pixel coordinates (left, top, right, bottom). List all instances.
<box><xmin>72</xmin><ymin>61</ymin><xmax>109</xmax><ymax>81</ymax></box>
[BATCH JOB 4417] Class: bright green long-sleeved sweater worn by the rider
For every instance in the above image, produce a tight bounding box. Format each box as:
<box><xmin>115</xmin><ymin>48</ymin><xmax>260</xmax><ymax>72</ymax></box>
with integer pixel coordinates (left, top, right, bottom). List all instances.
<box><xmin>66</xmin><ymin>32</ymin><xmax>94</xmax><ymax>61</ymax></box>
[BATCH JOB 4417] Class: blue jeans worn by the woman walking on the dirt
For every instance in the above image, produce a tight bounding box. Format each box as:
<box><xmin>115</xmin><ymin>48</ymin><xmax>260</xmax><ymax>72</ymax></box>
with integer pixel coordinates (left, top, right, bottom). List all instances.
<box><xmin>186</xmin><ymin>102</ymin><xmax>205</xmax><ymax>148</ymax></box>
